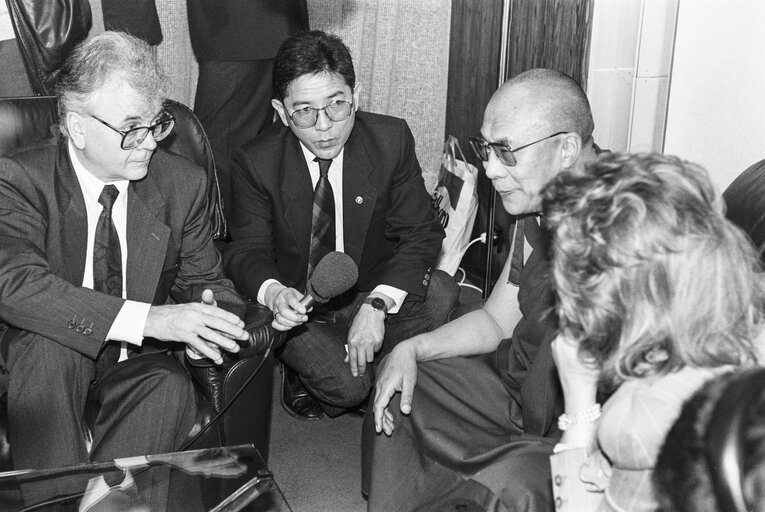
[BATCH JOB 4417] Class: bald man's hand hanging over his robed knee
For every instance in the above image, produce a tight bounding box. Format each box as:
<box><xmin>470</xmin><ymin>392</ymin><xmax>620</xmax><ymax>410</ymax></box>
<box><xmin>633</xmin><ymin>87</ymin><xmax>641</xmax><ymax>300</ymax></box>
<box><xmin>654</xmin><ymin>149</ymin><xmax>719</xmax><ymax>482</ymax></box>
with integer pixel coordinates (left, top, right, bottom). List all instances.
<box><xmin>373</xmin><ymin>341</ymin><xmax>417</xmax><ymax>436</ymax></box>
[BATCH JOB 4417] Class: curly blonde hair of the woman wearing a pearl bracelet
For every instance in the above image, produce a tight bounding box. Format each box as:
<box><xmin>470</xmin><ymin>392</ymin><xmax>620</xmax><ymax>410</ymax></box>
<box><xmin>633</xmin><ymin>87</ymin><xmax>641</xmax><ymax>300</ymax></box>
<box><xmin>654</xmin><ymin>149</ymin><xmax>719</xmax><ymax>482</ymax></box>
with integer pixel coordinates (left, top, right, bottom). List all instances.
<box><xmin>543</xmin><ymin>154</ymin><xmax>765</xmax><ymax>385</ymax></box>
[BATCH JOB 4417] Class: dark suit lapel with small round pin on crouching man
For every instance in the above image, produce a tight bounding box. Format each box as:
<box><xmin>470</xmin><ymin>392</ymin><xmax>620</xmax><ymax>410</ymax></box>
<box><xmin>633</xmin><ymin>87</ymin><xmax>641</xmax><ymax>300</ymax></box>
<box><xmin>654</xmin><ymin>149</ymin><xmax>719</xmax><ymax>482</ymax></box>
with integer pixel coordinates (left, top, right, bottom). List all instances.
<box><xmin>343</xmin><ymin>130</ymin><xmax>379</xmax><ymax>265</ymax></box>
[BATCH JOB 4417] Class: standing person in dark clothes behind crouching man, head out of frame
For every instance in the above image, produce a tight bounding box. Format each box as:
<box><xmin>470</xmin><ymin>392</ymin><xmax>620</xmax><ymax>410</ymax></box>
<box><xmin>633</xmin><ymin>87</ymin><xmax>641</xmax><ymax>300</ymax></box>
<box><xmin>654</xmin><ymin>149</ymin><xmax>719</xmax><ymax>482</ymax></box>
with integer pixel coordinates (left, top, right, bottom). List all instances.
<box><xmin>186</xmin><ymin>0</ymin><xmax>308</xmax><ymax>218</ymax></box>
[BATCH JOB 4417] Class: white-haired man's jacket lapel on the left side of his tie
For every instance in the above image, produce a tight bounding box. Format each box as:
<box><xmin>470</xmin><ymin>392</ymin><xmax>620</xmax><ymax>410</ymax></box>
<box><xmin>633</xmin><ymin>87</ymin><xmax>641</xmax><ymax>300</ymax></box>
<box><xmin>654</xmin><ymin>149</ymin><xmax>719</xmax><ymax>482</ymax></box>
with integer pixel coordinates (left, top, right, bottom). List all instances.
<box><xmin>53</xmin><ymin>137</ymin><xmax>88</xmax><ymax>285</ymax></box>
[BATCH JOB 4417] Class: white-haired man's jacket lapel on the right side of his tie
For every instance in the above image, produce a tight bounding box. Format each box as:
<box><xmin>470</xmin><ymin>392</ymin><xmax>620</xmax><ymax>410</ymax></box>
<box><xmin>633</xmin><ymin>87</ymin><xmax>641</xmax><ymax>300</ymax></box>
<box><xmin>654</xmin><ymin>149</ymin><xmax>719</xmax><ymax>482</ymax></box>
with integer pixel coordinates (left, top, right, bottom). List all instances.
<box><xmin>126</xmin><ymin>172</ymin><xmax>170</xmax><ymax>303</ymax></box>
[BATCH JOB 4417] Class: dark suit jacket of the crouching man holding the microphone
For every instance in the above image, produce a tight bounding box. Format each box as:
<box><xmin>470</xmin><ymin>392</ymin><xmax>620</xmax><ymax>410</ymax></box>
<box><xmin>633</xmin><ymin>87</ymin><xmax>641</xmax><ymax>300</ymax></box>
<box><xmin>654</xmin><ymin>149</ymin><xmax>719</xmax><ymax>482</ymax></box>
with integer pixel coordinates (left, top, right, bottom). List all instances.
<box><xmin>224</xmin><ymin>112</ymin><xmax>444</xmax><ymax>298</ymax></box>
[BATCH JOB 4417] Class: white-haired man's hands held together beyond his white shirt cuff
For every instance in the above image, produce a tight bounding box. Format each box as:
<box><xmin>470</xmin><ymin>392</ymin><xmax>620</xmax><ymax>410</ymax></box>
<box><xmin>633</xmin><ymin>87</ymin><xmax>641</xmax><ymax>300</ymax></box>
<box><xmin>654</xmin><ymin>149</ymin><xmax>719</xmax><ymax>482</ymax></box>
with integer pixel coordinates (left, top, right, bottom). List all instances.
<box><xmin>143</xmin><ymin>290</ymin><xmax>249</xmax><ymax>364</ymax></box>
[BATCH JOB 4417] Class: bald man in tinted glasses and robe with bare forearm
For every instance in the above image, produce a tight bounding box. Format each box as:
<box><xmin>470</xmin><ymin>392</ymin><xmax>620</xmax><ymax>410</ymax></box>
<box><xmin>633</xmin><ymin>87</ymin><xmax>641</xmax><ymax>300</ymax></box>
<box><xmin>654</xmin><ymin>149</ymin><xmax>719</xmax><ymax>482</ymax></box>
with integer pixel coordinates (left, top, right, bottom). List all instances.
<box><xmin>364</xmin><ymin>69</ymin><xmax>594</xmax><ymax>512</ymax></box>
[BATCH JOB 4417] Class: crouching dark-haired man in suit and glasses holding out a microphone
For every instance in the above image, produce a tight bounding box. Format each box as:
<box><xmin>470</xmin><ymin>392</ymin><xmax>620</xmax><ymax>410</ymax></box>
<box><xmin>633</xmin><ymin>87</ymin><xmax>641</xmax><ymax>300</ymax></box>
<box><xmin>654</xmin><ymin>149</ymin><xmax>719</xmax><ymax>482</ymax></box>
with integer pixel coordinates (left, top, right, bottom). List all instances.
<box><xmin>225</xmin><ymin>31</ymin><xmax>457</xmax><ymax>418</ymax></box>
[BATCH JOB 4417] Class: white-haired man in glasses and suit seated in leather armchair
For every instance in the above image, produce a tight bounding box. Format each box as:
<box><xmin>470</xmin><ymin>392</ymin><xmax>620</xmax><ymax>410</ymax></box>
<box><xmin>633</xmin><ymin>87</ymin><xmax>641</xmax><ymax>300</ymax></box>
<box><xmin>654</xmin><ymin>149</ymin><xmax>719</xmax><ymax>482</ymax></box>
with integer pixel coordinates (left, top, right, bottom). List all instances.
<box><xmin>0</xmin><ymin>31</ymin><xmax>247</xmax><ymax>504</ymax></box>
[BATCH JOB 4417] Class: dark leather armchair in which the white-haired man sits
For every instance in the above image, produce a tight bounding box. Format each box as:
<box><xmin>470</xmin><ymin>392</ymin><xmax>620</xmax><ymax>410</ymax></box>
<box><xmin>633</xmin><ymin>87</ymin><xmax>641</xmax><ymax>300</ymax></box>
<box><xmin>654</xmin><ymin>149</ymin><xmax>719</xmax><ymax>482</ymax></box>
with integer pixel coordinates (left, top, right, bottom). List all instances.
<box><xmin>0</xmin><ymin>96</ymin><xmax>274</xmax><ymax>503</ymax></box>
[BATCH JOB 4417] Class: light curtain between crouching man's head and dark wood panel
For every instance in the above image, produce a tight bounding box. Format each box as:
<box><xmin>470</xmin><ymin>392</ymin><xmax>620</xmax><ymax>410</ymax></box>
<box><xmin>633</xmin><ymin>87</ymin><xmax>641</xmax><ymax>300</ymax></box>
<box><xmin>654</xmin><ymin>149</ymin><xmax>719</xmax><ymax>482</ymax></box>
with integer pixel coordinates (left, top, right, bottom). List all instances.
<box><xmin>308</xmin><ymin>0</ymin><xmax>451</xmax><ymax>190</ymax></box>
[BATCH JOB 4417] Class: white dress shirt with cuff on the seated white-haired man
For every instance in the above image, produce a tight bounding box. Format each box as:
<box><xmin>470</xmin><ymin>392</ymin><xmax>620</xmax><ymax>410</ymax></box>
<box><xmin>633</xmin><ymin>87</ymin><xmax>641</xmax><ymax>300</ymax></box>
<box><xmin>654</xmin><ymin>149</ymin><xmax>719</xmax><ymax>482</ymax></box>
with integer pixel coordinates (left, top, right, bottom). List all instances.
<box><xmin>69</xmin><ymin>141</ymin><xmax>151</xmax><ymax>361</ymax></box>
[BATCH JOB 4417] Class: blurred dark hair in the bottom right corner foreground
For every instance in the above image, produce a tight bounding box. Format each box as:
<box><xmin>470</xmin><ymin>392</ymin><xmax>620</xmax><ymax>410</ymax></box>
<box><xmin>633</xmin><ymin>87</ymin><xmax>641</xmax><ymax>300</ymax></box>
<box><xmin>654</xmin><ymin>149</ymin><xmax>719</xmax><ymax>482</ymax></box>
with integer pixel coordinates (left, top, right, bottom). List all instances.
<box><xmin>653</xmin><ymin>367</ymin><xmax>765</xmax><ymax>512</ymax></box>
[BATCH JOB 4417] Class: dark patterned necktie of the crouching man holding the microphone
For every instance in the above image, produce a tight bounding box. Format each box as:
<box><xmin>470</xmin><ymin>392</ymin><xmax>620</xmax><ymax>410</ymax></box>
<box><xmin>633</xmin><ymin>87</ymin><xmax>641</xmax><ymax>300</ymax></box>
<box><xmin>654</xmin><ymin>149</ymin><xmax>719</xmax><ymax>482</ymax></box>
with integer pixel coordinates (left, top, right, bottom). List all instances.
<box><xmin>308</xmin><ymin>157</ymin><xmax>335</xmax><ymax>279</ymax></box>
